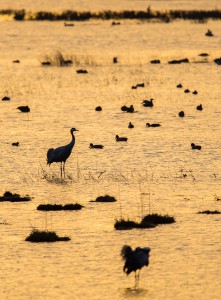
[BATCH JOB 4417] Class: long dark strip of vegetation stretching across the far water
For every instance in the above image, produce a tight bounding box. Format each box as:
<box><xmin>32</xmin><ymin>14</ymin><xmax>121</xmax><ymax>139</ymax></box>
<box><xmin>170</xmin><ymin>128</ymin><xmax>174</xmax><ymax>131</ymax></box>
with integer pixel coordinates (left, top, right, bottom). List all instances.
<box><xmin>0</xmin><ymin>7</ymin><xmax>221</xmax><ymax>21</ymax></box>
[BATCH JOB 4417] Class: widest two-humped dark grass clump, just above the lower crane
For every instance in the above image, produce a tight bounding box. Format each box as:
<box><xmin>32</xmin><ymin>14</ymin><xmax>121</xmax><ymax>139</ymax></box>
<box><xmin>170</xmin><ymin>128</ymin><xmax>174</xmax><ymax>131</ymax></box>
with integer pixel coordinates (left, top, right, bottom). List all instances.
<box><xmin>114</xmin><ymin>214</ymin><xmax>175</xmax><ymax>230</ymax></box>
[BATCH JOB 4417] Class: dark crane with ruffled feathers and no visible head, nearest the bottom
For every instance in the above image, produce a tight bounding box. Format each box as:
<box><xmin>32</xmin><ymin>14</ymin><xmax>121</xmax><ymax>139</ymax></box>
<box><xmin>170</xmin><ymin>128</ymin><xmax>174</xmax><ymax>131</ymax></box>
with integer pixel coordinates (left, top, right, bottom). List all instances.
<box><xmin>121</xmin><ymin>245</ymin><xmax>150</xmax><ymax>288</ymax></box>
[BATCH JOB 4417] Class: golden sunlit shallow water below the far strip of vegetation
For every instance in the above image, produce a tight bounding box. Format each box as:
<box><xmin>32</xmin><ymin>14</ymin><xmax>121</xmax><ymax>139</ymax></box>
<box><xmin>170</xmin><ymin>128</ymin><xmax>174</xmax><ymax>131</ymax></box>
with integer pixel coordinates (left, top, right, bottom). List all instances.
<box><xmin>0</xmin><ymin>2</ymin><xmax>221</xmax><ymax>300</ymax></box>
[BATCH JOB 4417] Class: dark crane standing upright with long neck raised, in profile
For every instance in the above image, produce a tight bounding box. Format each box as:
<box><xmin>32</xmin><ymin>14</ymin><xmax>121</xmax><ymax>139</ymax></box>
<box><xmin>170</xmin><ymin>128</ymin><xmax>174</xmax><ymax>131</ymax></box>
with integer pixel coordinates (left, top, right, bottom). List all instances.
<box><xmin>47</xmin><ymin>128</ymin><xmax>78</xmax><ymax>178</ymax></box>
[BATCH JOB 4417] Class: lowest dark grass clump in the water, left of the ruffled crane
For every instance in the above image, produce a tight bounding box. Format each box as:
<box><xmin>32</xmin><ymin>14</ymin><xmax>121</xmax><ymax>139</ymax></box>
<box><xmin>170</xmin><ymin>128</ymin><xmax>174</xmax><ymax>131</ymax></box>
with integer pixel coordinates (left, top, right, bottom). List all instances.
<box><xmin>25</xmin><ymin>229</ymin><xmax>70</xmax><ymax>243</ymax></box>
